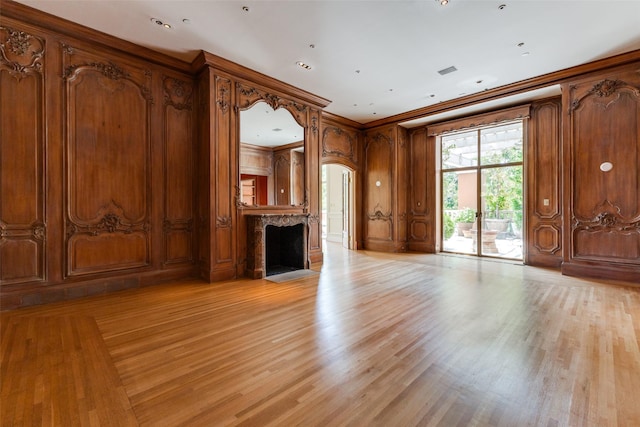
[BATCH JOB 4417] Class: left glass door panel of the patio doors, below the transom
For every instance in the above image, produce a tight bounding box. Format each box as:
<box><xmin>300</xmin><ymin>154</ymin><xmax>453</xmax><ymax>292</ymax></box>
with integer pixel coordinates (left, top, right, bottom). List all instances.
<box><xmin>442</xmin><ymin>170</ymin><xmax>478</xmax><ymax>254</ymax></box>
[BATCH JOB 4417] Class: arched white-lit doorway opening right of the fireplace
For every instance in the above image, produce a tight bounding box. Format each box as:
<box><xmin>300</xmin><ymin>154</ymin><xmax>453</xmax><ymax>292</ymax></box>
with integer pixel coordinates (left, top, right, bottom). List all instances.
<box><xmin>322</xmin><ymin>164</ymin><xmax>355</xmax><ymax>249</ymax></box>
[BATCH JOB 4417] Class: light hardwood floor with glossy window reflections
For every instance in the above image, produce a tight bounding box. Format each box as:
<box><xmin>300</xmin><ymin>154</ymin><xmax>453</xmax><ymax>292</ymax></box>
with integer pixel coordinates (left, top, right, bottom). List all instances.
<box><xmin>0</xmin><ymin>245</ymin><xmax>640</xmax><ymax>427</ymax></box>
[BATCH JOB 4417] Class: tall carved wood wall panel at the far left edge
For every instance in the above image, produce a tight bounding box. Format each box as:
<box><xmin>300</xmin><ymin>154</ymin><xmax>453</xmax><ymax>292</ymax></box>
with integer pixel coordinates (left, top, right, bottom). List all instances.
<box><xmin>0</xmin><ymin>20</ymin><xmax>48</xmax><ymax>289</ymax></box>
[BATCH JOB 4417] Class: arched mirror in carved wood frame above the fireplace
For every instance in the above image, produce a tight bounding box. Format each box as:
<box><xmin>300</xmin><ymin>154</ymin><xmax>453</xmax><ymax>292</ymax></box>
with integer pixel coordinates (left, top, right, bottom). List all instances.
<box><xmin>238</xmin><ymin>93</ymin><xmax>307</xmax><ymax>208</ymax></box>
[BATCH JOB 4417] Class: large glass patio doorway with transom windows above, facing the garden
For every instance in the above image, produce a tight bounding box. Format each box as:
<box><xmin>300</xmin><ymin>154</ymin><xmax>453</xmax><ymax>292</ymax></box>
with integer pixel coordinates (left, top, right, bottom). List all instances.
<box><xmin>439</xmin><ymin>120</ymin><xmax>524</xmax><ymax>260</ymax></box>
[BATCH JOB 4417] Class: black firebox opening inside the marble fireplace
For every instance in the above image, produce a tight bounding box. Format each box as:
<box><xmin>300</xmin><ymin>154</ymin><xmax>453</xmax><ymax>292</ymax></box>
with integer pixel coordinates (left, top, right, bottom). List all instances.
<box><xmin>265</xmin><ymin>224</ymin><xmax>304</xmax><ymax>276</ymax></box>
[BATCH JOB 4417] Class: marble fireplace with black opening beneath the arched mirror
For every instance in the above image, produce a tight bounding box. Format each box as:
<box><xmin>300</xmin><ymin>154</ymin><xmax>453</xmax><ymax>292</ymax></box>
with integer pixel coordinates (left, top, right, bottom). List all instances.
<box><xmin>246</xmin><ymin>214</ymin><xmax>309</xmax><ymax>279</ymax></box>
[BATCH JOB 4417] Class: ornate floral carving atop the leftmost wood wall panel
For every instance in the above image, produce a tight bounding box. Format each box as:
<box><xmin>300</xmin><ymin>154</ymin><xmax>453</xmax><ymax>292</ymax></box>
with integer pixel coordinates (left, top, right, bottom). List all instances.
<box><xmin>0</xmin><ymin>26</ymin><xmax>44</xmax><ymax>80</ymax></box>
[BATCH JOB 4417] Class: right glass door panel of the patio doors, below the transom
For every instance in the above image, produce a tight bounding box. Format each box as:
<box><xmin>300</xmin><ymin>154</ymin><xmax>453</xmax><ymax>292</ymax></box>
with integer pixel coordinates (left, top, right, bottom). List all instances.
<box><xmin>480</xmin><ymin>165</ymin><xmax>523</xmax><ymax>259</ymax></box>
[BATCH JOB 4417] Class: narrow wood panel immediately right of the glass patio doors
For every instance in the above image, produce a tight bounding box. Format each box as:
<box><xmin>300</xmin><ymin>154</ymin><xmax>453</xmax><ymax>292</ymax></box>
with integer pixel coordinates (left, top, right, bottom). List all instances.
<box><xmin>524</xmin><ymin>98</ymin><xmax>562</xmax><ymax>268</ymax></box>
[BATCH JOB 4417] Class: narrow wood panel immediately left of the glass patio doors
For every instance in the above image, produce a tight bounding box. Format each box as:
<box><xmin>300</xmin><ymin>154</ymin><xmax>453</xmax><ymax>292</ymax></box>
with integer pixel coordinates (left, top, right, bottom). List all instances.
<box><xmin>407</xmin><ymin>128</ymin><xmax>436</xmax><ymax>253</ymax></box>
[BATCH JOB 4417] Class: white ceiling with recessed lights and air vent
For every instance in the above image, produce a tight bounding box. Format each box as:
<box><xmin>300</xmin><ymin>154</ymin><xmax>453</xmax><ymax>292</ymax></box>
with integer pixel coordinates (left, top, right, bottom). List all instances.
<box><xmin>19</xmin><ymin>0</ymin><xmax>640</xmax><ymax>125</ymax></box>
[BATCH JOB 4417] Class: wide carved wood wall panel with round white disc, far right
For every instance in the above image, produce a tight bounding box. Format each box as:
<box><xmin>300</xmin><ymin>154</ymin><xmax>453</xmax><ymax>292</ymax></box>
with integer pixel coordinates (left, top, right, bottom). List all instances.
<box><xmin>562</xmin><ymin>63</ymin><xmax>640</xmax><ymax>281</ymax></box>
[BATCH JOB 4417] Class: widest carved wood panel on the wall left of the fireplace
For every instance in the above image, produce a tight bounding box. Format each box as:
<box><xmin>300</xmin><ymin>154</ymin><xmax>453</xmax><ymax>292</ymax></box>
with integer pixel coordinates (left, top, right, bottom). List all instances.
<box><xmin>63</xmin><ymin>46</ymin><xmax>153</xmax><ymax>276</ymax></box>
